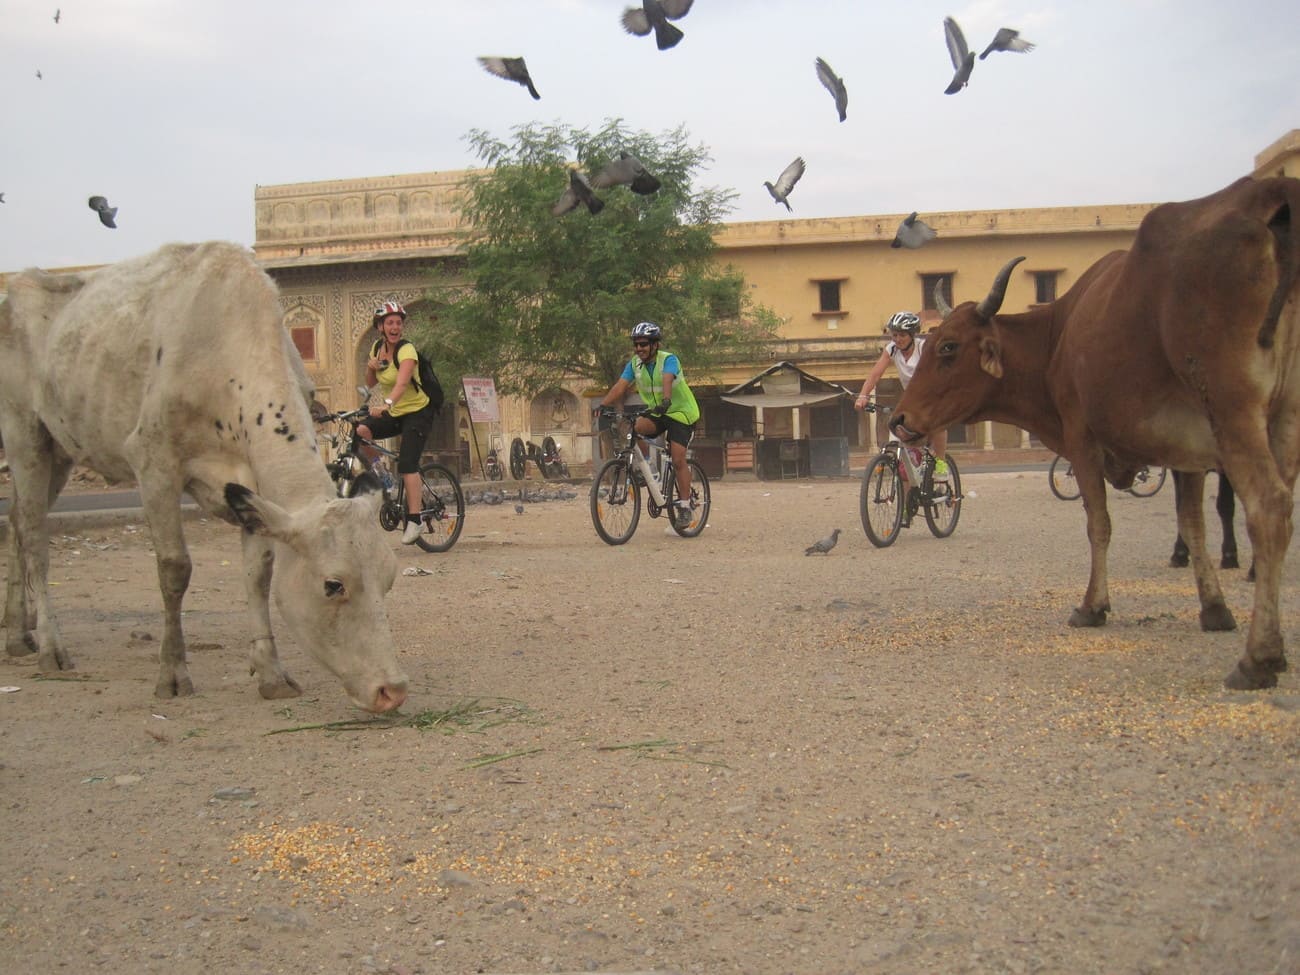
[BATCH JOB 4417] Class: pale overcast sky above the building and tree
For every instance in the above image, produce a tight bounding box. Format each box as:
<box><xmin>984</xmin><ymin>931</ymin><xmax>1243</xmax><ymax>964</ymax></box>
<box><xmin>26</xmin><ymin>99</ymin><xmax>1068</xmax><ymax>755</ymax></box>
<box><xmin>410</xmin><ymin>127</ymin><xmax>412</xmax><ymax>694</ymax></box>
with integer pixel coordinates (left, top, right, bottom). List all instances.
<box><xmin>0</xmin><ymin>0</ymin><xmax>1300</xmax><ymax>270</ymax></box>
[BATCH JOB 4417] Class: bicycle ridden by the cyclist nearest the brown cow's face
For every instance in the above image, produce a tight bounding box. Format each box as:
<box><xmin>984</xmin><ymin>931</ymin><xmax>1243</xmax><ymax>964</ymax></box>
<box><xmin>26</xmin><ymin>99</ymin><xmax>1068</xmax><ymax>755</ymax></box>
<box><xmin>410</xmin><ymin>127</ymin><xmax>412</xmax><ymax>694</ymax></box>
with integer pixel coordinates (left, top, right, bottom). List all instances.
<box><xmin>858</xmin><ymin>404</ymin><xmax>962</xmax><ymax>549</ymax></box>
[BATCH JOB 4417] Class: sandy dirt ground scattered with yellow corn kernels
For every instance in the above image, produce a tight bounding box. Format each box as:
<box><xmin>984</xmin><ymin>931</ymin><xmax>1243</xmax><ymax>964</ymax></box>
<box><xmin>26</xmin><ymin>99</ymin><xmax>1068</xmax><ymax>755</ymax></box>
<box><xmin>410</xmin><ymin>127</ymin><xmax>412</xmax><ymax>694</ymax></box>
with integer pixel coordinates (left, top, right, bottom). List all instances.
<box><xmin>0</xmin><ymin>471</ymin><xmax>1300</xmax><ymax>975</ymax></box>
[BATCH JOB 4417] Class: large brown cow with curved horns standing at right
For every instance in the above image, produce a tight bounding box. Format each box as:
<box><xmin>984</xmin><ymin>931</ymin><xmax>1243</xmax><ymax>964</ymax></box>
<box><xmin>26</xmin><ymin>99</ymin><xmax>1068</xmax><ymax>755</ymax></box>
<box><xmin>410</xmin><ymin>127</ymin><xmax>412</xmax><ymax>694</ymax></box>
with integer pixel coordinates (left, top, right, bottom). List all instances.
<box><xmin>891</xmin><ymin>178</ymin><xmax>1300</xmax><ymax>689</ymax></box>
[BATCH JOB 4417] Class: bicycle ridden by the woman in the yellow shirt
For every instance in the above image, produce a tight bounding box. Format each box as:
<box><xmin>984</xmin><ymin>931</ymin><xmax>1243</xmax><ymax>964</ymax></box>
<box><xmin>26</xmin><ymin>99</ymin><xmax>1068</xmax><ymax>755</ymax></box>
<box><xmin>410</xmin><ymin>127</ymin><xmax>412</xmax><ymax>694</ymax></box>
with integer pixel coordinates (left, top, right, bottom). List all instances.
<box><xmin>320</xmin><ymin>395</ymin><xmax>465</xmax><ymax>553</ymax></box>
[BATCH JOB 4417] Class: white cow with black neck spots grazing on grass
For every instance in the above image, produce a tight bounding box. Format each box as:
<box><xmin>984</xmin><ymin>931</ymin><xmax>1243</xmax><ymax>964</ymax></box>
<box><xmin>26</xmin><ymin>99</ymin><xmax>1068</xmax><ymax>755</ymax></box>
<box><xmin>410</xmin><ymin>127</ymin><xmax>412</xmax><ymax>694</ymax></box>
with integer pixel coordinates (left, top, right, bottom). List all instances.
<box><xmin>0</xmin><ymin>243</ymin><xmax>407</xmax><ymax>712</ymax></box>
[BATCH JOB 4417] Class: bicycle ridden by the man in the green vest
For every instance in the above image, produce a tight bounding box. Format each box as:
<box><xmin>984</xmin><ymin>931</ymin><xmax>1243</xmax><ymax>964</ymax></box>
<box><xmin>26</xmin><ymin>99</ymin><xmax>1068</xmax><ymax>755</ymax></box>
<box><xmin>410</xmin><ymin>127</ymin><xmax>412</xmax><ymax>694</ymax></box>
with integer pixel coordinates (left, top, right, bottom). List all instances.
<box><xmin>590</xmin><ymin>410</ymin><xmax>711</xmax><ymax>545</ymax></box>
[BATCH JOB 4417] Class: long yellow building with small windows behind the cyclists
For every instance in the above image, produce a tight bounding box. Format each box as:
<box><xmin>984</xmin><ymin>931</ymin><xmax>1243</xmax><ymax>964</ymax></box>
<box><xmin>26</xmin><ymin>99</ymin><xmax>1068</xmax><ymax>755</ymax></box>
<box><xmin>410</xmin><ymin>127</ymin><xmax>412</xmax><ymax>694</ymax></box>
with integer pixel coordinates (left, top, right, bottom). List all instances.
<box><xmin>254</xmin><ymin>130</ymin><xmax>1300</xmax><ymax>473</ymax></box>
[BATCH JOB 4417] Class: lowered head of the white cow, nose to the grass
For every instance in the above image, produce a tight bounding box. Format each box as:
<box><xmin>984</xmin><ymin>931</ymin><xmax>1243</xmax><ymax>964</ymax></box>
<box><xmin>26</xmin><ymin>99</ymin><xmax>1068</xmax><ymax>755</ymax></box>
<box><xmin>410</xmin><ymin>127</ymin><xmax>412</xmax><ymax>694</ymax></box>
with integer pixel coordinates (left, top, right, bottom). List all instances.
<box><xmin>225</xmin><ymin>484</ymin><xmax>407</xmax><ymax>714</ymax></box>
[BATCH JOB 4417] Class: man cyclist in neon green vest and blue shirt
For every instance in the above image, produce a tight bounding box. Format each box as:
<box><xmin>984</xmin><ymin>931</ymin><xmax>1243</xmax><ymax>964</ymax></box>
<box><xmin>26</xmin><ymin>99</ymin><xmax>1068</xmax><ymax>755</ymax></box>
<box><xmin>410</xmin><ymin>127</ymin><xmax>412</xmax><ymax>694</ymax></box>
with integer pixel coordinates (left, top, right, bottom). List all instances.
<box><xmin>597</xmin><ymin>321</ymin><xmax>699</xmax><ymax>525</ymax></box>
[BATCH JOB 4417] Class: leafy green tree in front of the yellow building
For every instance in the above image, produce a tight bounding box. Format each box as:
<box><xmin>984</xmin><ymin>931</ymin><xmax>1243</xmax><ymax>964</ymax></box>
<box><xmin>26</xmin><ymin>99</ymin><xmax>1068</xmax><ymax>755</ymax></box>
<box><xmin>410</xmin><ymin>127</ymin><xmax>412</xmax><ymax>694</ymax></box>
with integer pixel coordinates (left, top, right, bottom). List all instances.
<box><xmin>415</xmin><ymin>120</ymin><xmax>777</xmax><ymax>395</ymax></box>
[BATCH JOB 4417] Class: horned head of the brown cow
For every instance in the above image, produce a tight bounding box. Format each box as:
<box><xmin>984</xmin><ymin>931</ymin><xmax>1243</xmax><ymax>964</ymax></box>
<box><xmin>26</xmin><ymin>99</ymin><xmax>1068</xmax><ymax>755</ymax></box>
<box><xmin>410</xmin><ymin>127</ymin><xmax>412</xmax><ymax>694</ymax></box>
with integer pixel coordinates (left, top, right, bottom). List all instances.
<box><xmin>889</xmin><ymin>257</ymin><xmax>1024</xmax><ymax>443</ymax></box>
